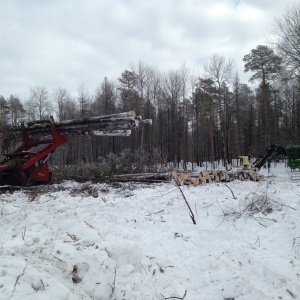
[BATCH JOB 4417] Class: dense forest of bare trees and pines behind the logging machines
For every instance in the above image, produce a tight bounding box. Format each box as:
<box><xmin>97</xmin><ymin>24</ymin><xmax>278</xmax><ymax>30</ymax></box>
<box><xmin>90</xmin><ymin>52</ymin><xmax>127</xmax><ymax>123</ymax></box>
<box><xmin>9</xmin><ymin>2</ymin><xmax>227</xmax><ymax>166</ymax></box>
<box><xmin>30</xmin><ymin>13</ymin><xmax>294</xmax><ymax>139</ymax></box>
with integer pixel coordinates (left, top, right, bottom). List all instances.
<box><xmin>0</xmin><ymin>4</ymin><xmax>300</xmax><ymax>173</ymax></box>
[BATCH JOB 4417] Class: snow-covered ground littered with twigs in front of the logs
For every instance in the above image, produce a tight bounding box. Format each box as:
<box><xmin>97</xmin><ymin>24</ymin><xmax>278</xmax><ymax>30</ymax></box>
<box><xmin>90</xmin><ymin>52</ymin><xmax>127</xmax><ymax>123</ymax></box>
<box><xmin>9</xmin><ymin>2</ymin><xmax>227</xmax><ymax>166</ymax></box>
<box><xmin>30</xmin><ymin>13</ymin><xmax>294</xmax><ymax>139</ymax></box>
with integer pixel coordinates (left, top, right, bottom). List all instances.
<box><xmin>0</xmin><ymin>165</ymin><xmax>300</xmax><ymax>300</ymax></box>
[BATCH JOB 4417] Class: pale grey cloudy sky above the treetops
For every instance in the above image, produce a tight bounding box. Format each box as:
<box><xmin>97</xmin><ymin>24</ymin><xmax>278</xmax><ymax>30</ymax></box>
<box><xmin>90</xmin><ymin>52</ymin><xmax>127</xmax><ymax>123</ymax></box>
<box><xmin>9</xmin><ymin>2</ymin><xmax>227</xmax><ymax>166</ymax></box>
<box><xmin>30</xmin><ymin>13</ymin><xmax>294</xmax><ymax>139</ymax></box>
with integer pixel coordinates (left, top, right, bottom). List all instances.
<box><xmin>0</xmin><ymin>0</ymin><xmax>293</xmax><ymax>101</ymax></box>
